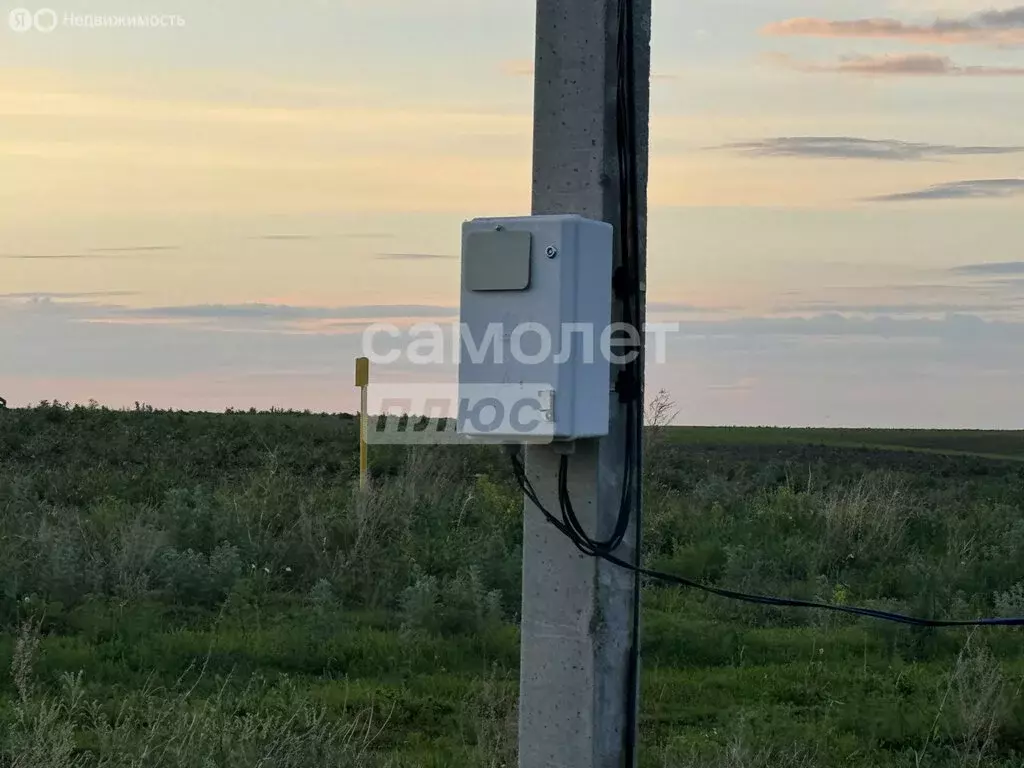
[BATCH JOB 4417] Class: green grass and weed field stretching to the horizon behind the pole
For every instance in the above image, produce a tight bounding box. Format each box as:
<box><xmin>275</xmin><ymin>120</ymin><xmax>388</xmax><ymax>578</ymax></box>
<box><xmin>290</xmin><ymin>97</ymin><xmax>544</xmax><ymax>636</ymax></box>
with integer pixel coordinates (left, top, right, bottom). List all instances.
<box><xmin>0</xmin><ymin>404</ymin><xmax>1024</xmax><ymax>768</ymax></box>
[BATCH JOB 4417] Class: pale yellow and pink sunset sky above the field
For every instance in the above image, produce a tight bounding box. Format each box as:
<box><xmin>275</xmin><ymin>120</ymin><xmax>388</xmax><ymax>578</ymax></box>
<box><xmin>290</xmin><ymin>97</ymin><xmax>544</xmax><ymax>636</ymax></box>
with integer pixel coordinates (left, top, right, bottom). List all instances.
<box><xmin>0</xmin><ymin>0</ymin><xmax>1024</xmax><ymax>429</ymax></box>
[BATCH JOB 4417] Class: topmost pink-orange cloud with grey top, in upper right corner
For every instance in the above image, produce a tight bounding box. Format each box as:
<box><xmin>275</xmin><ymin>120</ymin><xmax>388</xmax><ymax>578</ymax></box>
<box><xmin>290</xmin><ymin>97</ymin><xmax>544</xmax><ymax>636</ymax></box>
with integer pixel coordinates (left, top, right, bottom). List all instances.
<box><xmin>762</xmin><ymin>5</ymin><xmax>1024</xmax><ymax>47</ymax></box>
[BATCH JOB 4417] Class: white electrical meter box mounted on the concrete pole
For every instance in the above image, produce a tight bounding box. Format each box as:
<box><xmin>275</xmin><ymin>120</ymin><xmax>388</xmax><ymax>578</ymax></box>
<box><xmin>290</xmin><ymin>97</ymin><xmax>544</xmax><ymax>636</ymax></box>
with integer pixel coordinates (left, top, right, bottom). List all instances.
<box><xmin>458</xmin><ymin>216</ymin><xmax>613</xmax><ymax>442</ymax></box>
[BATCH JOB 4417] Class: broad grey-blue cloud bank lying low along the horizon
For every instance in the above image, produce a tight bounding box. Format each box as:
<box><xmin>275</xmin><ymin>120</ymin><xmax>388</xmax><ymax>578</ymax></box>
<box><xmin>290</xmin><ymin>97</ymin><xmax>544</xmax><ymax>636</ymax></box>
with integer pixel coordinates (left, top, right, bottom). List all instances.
<box><xmin>8</xmin><ymin>296</ymin><xmax>1024</xmax><ymax>428</ymax></box>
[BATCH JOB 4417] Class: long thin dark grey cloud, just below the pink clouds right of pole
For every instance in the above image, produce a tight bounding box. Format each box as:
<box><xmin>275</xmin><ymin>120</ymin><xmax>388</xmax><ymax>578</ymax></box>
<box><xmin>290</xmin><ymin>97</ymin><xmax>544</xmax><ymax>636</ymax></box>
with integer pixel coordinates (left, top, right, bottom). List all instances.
<box><xmin>711</xmin><ymin>136</ymin><xmax>1024</xmax><ymax>161</ymax></box>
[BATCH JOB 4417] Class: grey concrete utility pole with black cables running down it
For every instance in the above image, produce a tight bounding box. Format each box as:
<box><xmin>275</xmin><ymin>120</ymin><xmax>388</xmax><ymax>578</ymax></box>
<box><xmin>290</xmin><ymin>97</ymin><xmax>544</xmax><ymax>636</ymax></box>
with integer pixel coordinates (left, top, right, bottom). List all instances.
<box><xmin>519</xmin><ymin>0</ymin><xmax>651</xmax><ymax>768</ymax></box>
